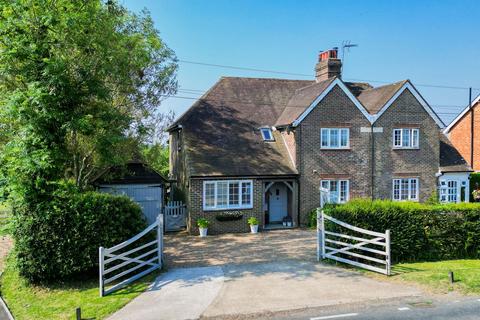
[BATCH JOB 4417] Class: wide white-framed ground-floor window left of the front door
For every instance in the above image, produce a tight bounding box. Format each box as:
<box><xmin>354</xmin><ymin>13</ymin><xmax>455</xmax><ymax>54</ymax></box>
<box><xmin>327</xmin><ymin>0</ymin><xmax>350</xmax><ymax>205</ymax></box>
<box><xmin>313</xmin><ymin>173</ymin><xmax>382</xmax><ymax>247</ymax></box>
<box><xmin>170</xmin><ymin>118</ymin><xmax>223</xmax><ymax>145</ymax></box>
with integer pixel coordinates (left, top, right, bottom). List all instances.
<box><xmin>203</xmin><ymin>180</ymin><xmax>253</xmax><ymax>210</ymax></box>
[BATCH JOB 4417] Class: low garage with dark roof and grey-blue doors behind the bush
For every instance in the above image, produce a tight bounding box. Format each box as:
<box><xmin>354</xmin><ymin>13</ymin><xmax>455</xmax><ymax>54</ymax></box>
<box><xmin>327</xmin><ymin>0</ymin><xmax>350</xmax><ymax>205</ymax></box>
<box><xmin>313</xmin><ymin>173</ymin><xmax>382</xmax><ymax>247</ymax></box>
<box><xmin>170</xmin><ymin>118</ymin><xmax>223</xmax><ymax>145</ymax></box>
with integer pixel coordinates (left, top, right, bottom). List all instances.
<box><xmin>93</xmin><ymin>161</ymin><xmax>168</xmax><ymax>224</ymax></box>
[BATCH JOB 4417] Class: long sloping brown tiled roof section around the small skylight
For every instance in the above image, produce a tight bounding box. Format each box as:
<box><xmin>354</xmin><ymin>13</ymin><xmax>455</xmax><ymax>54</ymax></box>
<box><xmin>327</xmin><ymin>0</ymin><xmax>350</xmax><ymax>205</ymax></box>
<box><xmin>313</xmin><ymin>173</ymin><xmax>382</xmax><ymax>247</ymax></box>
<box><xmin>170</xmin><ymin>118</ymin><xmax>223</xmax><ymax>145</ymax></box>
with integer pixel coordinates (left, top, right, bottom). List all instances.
<box><xmin>176</xmin><ymin>77</ymin><xmax>313</xmax><ymax>176</ymax></box>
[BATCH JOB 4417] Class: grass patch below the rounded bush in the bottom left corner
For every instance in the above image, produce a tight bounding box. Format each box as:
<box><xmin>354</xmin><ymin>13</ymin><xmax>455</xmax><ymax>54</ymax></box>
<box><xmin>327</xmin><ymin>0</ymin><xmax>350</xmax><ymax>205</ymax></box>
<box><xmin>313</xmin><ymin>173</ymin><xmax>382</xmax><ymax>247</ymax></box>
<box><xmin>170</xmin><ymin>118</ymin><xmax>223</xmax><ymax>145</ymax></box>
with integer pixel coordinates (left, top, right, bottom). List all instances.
<box><xmin>1</xmin><ymin>258</ymin><xmax>158</xmax><ymax>320</ymax></box>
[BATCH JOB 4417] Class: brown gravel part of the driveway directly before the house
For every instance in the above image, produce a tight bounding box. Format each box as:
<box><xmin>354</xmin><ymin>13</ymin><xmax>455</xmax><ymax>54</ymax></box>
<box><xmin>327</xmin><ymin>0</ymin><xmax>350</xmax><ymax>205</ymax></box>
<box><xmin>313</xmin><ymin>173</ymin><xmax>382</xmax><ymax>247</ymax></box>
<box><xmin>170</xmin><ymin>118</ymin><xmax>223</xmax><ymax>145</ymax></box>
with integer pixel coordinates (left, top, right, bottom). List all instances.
<box><xmin>165</xmin><ymin>229</ymin><xmax>316</xmax><ymax>268</ymax></box>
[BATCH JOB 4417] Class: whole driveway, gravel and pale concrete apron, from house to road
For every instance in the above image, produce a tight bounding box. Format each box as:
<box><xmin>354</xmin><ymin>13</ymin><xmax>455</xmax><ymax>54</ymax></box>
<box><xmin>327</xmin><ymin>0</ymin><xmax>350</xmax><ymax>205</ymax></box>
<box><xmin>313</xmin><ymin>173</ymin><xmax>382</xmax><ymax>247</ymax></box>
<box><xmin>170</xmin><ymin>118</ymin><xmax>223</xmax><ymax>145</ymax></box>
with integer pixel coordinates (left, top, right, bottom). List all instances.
<box><xmin>110</xmin><ymin>229</ymin><xmax>421</xmax><ymax>320</ymax></box>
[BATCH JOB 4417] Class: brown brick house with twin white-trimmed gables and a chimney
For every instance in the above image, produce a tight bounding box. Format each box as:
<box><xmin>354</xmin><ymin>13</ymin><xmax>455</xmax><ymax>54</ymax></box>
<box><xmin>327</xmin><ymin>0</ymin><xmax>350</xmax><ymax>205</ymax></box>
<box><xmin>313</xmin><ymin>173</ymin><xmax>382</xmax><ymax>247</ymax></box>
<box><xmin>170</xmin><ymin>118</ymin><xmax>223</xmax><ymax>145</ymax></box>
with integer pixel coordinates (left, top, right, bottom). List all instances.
<box><xmin>168</xmin><ymin>49</ymin><xmax>471</xmax><ymax>233</ymax></box>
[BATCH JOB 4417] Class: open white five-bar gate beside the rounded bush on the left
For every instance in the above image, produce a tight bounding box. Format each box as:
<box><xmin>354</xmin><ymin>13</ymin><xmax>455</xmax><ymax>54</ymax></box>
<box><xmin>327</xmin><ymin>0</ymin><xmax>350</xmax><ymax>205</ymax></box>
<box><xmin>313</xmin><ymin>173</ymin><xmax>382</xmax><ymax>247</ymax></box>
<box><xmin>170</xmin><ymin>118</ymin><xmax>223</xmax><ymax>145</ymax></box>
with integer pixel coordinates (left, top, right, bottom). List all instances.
<box><xmin>98</xmin><ymin>215</ymin><xmax>163</xmax><ymax>297</ymax></box>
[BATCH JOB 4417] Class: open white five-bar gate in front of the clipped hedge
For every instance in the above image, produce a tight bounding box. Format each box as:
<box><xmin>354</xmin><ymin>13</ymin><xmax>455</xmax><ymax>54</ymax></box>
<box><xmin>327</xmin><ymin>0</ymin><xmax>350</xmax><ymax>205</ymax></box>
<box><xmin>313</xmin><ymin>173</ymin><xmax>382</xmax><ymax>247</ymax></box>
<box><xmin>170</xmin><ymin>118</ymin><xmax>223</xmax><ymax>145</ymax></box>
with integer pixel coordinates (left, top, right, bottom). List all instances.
<box><xmin>317</xmin><ymin>209</ymin><xmax>391</xmax><ymax>275</ymax></box>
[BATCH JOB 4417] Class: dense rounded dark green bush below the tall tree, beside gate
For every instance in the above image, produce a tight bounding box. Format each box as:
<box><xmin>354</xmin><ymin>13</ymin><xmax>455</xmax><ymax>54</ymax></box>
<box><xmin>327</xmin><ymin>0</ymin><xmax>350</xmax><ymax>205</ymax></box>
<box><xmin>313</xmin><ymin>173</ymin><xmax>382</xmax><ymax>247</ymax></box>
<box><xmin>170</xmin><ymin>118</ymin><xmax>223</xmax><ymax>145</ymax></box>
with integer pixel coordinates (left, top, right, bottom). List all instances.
<box><xmin>13</xmin><ymin>189</ymin><xmax>146</xmax><ymax>282</ymax></box>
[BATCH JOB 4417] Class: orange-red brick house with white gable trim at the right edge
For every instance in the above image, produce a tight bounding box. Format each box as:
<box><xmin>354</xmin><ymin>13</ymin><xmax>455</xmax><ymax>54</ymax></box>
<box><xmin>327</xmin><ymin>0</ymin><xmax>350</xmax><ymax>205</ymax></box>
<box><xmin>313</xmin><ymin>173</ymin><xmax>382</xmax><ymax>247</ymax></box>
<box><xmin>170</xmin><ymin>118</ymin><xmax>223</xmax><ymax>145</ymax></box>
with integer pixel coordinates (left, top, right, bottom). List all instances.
<box><xmin>444</xmin><ymin>96</ymin><xmax>480</xmax><ymax>171</ymax></box>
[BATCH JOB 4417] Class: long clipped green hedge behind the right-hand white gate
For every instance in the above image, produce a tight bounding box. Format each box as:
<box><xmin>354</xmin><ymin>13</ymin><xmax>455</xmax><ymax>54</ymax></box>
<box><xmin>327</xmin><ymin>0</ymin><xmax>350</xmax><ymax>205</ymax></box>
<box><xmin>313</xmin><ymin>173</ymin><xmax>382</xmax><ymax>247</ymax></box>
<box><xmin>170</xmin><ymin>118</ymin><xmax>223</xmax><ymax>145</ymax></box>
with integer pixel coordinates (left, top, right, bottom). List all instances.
<box><xmin>311</xmin><ymin>199</ymin><xmax>480</xmax><ymax>262</ymax></box>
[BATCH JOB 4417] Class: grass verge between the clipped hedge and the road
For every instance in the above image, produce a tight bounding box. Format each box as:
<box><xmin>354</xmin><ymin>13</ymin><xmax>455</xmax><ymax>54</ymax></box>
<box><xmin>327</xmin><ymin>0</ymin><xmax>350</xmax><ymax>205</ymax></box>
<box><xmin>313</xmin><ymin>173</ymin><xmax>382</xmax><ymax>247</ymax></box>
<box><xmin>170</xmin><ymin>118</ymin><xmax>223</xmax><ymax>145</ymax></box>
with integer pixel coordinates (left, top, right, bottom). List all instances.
<box><xmin>392</xmin><ymin>260</ymin><xmax>480</xmax><ymax>294</ymax></box>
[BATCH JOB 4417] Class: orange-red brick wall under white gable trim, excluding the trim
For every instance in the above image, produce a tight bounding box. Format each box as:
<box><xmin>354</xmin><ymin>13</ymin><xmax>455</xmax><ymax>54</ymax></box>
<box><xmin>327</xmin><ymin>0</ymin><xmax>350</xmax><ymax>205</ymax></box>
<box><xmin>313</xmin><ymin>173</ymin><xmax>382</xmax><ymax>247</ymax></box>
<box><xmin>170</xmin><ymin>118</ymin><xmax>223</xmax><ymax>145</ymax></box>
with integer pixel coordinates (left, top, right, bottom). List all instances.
<box><xmin>448</xmin><ymin>103</ymin><xmax>480</xmax><ymax>171</ymax></box>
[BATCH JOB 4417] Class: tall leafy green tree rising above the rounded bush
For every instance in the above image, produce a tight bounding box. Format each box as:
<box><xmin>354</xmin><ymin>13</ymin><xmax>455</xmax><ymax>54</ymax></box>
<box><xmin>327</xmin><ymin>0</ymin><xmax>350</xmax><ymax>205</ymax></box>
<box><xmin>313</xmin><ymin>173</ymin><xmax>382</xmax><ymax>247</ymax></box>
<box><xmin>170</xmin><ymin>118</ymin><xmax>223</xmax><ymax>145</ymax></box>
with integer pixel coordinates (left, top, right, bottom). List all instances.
<box><xmin>0</xmin><ymin>0</ymin><xmax>177</xmax><ymax>201</ymax></box>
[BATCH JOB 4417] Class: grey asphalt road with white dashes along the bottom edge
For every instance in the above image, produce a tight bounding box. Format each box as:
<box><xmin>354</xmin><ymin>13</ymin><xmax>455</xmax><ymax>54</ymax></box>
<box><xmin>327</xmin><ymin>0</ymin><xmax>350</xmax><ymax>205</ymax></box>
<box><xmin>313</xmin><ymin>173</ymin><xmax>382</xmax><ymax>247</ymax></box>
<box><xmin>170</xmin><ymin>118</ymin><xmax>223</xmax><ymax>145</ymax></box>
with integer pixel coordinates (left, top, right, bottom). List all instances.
<box><xmin>251</xmin><ymin>298</ymin><xmax>480</xmax><ymax>320</ymax></box>
